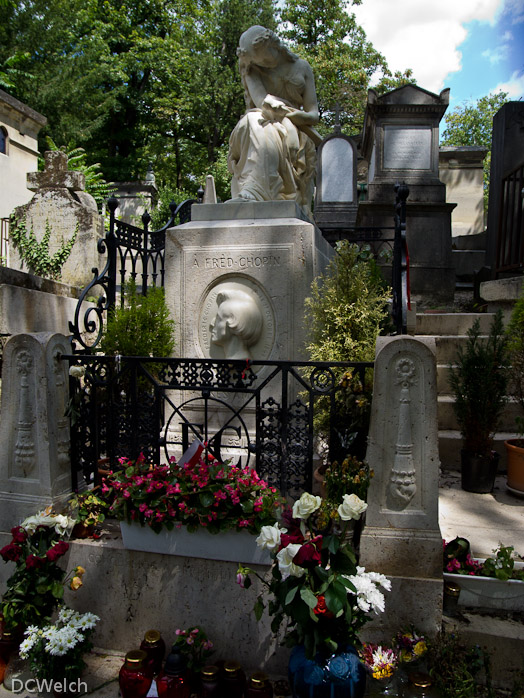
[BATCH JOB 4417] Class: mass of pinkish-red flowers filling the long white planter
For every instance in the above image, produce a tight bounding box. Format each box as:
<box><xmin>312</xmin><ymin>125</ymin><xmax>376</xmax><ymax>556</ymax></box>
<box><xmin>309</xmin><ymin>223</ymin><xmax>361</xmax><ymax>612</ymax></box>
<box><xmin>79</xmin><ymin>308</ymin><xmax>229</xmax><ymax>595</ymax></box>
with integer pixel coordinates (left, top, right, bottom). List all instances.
<box><xmin>102</xmin><ymin>455</ymin><xmax>284</xmax><ymax>533</ymax></box>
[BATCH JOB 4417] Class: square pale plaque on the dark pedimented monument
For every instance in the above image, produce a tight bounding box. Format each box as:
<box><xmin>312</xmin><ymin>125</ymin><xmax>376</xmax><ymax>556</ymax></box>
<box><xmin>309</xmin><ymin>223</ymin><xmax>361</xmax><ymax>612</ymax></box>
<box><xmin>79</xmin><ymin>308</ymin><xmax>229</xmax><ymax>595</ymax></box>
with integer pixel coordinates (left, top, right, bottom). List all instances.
<box><xmin>384</xmin><ymin>126</ymin><xmax>432</xmax><ymax>170</ymax></box>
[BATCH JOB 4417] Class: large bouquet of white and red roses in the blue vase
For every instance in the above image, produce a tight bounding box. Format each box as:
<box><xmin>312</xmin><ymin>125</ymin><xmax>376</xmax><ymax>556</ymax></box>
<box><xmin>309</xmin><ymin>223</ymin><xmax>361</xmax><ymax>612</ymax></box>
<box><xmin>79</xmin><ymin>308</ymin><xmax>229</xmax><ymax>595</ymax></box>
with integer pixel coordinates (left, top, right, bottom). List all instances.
<box><xmin>237</xmin><ymin>492</ymin><xmax>391</xmax><ymax>659</ymax></box>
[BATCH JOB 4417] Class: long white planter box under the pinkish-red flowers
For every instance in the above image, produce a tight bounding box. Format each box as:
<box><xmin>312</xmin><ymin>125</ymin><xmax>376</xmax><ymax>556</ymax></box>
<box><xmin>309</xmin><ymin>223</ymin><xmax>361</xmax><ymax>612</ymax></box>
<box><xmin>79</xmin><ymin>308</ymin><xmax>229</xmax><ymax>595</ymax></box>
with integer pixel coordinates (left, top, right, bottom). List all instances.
<box><xmin>120</xmin><ymin>521</ymin><xmax>271</xmax><ymax>565</ymax></box>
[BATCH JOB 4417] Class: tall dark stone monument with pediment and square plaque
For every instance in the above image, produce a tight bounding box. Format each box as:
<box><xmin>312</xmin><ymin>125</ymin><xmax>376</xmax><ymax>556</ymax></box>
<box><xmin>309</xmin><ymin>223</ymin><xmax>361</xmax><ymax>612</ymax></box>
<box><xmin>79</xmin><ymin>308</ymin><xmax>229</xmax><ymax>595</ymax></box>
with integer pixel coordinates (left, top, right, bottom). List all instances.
<box><xmin>357</xmin><ymin>85</ymin><xmax>455</xmax><ymax>302</ymax></box>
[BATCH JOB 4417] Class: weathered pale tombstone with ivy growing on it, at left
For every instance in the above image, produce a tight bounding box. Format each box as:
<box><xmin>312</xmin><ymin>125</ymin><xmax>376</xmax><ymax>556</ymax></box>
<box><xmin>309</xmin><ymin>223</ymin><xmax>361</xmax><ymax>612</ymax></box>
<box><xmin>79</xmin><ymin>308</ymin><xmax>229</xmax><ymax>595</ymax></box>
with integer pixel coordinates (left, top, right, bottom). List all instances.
<box><xmin>10</xmin><ymin>150</ymin><xmax>104</xmax><ymax>286</ymax></box>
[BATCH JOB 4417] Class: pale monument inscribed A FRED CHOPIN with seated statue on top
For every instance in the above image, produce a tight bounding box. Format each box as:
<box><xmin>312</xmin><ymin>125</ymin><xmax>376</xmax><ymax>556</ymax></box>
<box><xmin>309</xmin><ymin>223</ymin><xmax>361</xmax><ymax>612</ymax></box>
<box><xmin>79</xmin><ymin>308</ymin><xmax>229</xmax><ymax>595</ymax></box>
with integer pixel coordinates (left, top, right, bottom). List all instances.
<box><xmin>165</xmin><ymin>26</ymin><xmax>333</xmax><ymax>462</ymax></box>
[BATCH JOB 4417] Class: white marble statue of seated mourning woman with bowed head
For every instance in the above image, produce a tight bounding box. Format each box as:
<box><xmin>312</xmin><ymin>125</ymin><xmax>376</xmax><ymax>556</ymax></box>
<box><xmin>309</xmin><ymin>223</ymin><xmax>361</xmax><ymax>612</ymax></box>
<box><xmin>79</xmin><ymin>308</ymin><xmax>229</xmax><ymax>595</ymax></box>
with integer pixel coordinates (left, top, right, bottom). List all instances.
<box><xmin>228</xmin><ymin>26</ymin><xmax>320</xmax><ymax>209</ymax></box>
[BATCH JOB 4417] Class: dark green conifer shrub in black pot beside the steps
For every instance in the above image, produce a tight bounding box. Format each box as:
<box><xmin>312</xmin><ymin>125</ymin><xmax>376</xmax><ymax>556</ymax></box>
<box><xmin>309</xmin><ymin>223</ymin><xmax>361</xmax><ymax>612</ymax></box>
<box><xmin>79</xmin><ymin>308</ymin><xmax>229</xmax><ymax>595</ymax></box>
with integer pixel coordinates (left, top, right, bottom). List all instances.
<box><xmin>449</xmin><ymin>311</ymin><xmax>508</xmax><ymax>493</ymax></box>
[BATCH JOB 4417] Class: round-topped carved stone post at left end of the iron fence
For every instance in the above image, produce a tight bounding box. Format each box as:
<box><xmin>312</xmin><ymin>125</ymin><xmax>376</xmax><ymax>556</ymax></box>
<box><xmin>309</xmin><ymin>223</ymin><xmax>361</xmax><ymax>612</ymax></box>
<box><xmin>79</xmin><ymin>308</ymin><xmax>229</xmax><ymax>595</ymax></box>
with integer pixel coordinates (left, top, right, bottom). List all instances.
<box><xmin>0</xmin><ymin>332</ymin><xmax>71</xmax><ymax>531</ymax></box>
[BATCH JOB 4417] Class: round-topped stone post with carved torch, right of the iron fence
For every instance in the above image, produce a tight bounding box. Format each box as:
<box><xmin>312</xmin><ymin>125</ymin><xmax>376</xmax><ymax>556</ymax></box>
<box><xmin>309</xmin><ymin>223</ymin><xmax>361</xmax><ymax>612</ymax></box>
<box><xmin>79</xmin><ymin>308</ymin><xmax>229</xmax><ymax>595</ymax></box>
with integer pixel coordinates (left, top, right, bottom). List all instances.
<box><xmin>360</xmin><ymin>337</ymin><xmax>442</xmax><ymax>637</ymax></box>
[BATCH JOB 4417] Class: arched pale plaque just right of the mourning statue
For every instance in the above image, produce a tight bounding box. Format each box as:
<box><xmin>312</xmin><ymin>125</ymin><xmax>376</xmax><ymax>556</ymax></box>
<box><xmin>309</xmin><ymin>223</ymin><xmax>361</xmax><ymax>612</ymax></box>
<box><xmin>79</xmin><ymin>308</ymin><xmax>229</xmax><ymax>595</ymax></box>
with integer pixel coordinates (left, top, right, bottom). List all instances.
<box><xmin>321</xmin><ymin>138</ymin><xmax>354</xmax><ymax>203</ymax></box>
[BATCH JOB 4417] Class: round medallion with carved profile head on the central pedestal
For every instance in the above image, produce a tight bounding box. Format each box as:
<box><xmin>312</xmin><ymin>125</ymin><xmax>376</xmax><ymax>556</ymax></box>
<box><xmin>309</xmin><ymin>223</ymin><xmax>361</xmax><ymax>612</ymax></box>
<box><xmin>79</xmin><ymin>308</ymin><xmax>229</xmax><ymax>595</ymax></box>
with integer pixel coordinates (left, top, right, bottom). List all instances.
<box><xmin>199</xmin><ymin>277</ymin><xmax>274</xmax><ymax>359</ymax></box>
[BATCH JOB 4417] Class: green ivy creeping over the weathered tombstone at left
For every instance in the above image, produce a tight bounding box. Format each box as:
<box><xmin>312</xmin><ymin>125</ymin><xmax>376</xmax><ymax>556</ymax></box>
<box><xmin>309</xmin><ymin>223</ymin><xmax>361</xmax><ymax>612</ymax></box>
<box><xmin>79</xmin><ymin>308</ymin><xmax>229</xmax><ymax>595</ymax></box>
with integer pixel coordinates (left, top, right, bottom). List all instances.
<box><xmin>9</xmin><ymin>216</ymin><xmax>79</xmax><ymax>280</ymax></box>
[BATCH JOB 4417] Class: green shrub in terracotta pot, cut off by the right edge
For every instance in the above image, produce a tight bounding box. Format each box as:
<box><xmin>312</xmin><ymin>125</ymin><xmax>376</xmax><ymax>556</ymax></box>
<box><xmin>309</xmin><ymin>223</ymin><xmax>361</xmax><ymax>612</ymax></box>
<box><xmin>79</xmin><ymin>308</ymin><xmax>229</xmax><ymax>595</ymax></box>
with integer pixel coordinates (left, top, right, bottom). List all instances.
<box><xmin>505</xmin><ymin>293</ymin><xmax>524</xmax><ymax>493</ymax></box>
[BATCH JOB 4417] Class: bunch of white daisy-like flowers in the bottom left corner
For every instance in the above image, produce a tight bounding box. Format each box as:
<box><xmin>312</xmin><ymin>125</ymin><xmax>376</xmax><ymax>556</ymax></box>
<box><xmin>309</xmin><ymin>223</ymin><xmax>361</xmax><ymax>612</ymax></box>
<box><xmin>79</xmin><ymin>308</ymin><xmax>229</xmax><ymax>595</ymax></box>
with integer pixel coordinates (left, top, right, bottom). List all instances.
<box><xmin>20</xmin><ymin>606</ymin><xmax>100</xmax><ymax>682</ymax></box>
